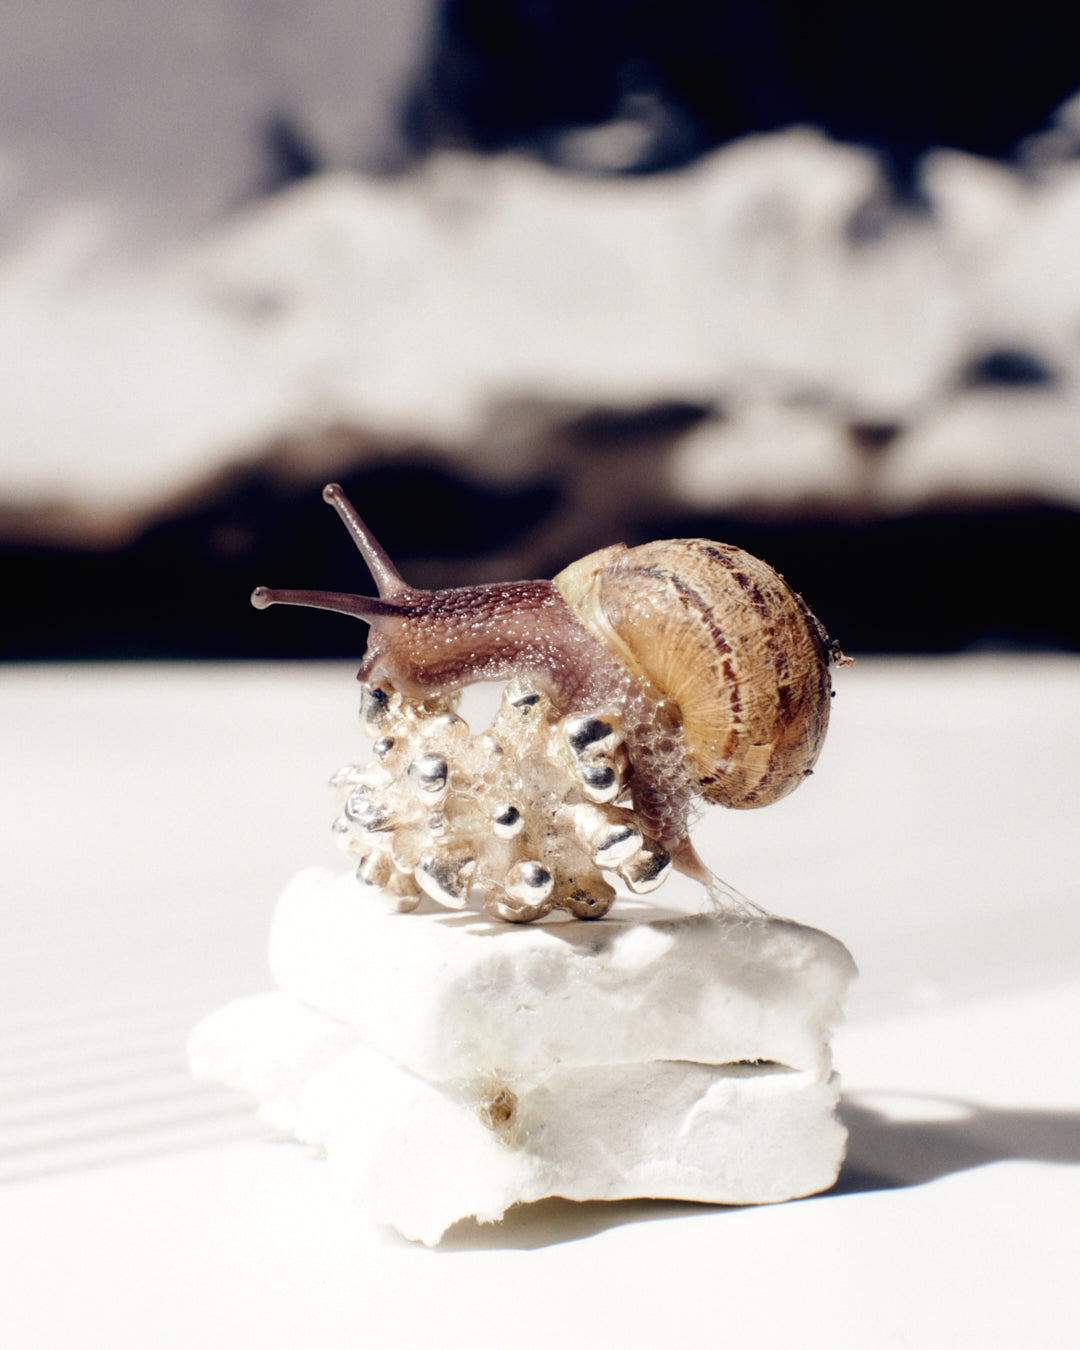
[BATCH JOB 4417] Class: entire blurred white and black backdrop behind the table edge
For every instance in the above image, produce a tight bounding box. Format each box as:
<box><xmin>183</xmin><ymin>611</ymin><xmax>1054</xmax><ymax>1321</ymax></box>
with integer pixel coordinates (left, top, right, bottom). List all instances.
<box><xmin>0</xmin><ymin>0</ymin><xmax>1080</xmax><ymax>660</ymax></box>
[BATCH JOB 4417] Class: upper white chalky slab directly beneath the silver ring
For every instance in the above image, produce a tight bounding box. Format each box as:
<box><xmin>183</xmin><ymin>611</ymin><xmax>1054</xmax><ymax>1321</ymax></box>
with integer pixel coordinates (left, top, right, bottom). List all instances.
<box><xmin>270</xmin><ymin>868</ymin><xmax>855</xmax><ymax>1081</ymax></box>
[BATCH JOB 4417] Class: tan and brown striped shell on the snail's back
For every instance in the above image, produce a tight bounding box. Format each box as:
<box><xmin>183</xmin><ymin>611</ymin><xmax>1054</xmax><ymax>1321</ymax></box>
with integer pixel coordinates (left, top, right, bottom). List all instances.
<box><xmin>555</xmin><ymin>539</ymin><xmax>832</xmax><ymax>809</ymax></box>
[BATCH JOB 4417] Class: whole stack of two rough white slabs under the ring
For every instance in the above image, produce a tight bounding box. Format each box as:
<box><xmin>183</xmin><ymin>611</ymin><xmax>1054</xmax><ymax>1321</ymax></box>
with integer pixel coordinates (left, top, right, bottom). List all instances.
<box><xmin>190</xmin><ymin>869</ymin><xmax>855</xmax><ymax>1242</ymax></box>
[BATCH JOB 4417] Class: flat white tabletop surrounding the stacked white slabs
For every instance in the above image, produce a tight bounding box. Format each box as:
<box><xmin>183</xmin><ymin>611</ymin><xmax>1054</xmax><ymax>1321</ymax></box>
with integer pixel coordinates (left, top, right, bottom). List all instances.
<box><xmin>0</xmin><ymin>656</ymin><xmax>1080</xmax><ymax>1350</ymax></box>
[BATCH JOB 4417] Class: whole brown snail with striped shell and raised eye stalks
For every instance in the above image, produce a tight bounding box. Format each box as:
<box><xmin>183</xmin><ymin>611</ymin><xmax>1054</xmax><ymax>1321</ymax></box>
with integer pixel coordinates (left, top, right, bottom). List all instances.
<box><xmin>251</xmin><ymin>483</ymin><xmax>848</xmax><ymax>890</ymax></box>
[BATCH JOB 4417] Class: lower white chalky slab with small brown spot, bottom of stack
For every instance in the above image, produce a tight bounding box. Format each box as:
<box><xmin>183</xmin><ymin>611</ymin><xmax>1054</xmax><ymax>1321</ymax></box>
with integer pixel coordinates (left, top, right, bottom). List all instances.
<box><xmin>190</xmin><ymin>994</ymin><xmax>846</xmax><ymax>1243</ymax></box>
